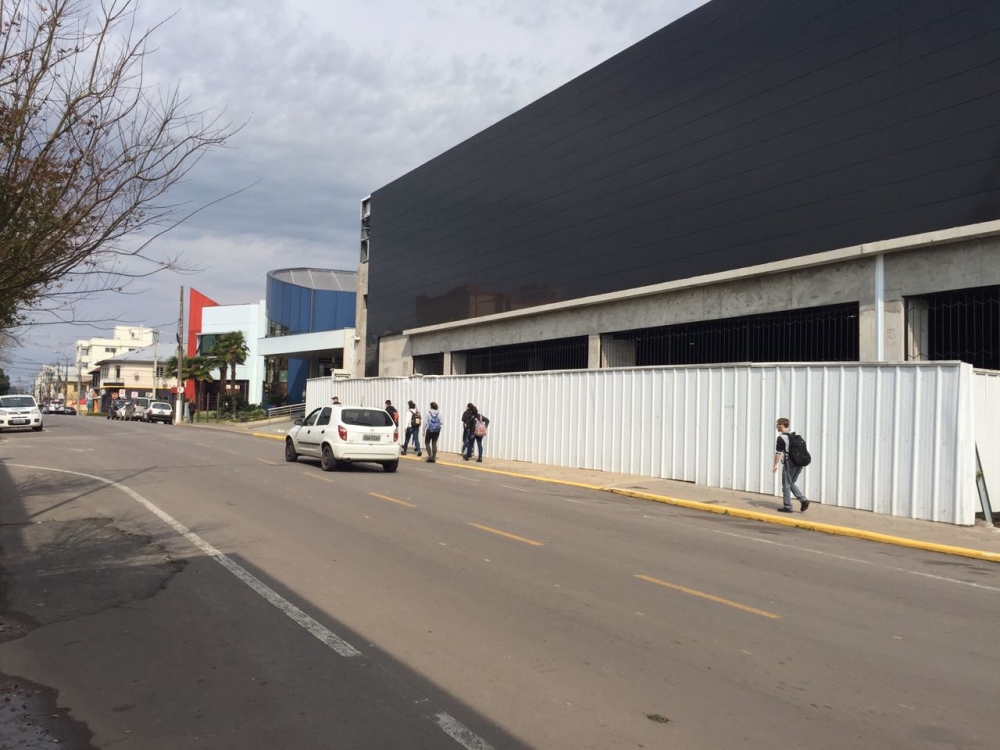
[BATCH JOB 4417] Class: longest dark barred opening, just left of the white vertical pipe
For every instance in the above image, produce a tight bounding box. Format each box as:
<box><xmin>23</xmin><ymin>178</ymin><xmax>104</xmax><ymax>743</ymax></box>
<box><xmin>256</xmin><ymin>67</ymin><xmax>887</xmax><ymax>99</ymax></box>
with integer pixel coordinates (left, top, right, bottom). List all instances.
<box><xmin>602</xmin><ymin>302</ymin><xmax>859</xmax><ymax>367</ymax></box>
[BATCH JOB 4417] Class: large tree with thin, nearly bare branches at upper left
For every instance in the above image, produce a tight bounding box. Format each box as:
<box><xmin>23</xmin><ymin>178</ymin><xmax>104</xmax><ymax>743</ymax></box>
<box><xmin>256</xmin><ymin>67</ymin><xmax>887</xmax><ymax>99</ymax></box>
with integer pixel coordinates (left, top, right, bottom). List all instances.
<box><xmin>0</xmin><ymin>0</ymin><xmax>242</xmax><ymax>330</ymax></box>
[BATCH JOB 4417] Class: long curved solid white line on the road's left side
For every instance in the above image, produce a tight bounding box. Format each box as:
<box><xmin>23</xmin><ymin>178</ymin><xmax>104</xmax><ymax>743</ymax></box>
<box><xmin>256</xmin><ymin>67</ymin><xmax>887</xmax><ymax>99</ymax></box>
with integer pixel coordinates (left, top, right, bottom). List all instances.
<box><xmin>10</xmin><ymin>464</ymin><xmax>361</xmax><ymax>658</ymax></box>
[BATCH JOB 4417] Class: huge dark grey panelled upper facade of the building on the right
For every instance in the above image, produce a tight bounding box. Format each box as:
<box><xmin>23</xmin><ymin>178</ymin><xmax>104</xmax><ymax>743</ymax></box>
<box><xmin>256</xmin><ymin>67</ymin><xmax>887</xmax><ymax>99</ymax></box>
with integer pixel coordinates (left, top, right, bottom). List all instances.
<box><xmin>359</xmin><ymin>0</ymin><xmax>1000</xmax><ymax>375</ymax></box>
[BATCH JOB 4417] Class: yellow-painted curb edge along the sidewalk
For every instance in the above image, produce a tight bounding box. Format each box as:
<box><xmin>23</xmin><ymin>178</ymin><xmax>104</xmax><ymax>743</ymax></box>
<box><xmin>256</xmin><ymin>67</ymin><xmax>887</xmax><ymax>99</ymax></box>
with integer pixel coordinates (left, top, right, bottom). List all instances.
<box><xmin>236</xmin><ymin>432</ymin><xmax>1000</xmax><ymax>563</ymax></box>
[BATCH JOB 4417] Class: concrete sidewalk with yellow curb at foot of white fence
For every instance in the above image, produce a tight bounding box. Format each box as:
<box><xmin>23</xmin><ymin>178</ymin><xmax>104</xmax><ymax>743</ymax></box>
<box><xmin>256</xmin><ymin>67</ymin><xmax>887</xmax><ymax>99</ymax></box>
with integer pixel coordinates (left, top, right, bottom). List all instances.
<box><xmin>185</xmin><ymin>420</ymin><xmax>1000</xmax><ymax>562</ymax></box>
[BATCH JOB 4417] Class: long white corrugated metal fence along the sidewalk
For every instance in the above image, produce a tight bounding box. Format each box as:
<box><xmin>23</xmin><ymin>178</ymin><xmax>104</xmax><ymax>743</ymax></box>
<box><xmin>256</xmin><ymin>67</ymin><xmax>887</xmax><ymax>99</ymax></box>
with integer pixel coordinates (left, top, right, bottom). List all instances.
<box><xmin>306</xmin><ymin>362</ymin><xmax>976</xmax><ymax>524</ymax></box>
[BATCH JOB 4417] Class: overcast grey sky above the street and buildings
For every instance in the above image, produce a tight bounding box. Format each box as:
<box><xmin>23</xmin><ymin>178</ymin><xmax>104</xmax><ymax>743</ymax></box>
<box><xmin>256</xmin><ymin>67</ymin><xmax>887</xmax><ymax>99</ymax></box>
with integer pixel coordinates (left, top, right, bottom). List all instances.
<box><xmin>0</xmin><ymin>0</ymin><xmax>705</xmax><ymax>384</ymax></box>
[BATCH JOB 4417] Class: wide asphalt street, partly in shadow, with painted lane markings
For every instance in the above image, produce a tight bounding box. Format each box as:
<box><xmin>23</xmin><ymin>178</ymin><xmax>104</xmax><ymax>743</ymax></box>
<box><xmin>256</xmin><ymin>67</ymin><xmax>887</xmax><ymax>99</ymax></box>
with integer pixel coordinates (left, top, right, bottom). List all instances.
<box><xmin>0</xmin><ymin>416</ymin><xmax>1000</xmax><ymax>750</ymax></box>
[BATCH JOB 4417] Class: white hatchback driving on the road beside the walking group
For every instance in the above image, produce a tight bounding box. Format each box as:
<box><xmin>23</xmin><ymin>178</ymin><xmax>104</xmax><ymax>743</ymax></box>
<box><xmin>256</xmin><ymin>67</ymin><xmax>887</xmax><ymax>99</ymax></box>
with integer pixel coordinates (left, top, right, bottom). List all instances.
<box><xmin>285</xmin><ymin>404</ymin><xmax>399</xmax><ymax>472</ymax></box>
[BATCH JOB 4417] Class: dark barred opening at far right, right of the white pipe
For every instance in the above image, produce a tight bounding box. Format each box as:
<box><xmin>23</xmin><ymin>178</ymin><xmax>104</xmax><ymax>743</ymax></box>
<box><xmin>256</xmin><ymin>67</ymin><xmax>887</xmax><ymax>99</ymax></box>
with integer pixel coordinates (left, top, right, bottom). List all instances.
<box><xmin>923</xmin><ymin>286</ymin><xmax>1000</xmax><ymax>370</ymax></box>
